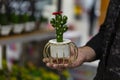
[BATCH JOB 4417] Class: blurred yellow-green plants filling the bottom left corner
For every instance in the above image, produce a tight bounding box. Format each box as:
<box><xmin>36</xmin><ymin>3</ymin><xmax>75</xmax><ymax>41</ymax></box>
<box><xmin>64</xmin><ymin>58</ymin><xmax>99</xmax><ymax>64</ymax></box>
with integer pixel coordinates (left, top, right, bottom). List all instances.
<box><xmin>0</xmin><ymin>63</ymin><xmax>60</xmax><ymax>80</ymax></box>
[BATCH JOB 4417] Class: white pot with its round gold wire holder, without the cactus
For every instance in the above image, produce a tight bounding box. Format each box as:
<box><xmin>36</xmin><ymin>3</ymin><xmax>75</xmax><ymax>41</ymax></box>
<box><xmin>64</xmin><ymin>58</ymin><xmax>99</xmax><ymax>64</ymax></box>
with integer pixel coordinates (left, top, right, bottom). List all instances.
<box><xmin>44</xmin><ymin>39</ymin><xmax>77</xmax><ymax>63</ymax></box>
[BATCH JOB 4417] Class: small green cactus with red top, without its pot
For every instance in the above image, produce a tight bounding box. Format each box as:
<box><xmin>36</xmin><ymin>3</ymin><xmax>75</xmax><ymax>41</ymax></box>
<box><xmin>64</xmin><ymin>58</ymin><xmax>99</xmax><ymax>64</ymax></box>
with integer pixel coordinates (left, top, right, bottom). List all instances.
<box><xmin>50</xmin><ymin>12</ymin><xmax>68</xmax><ymax>42</ymax></box>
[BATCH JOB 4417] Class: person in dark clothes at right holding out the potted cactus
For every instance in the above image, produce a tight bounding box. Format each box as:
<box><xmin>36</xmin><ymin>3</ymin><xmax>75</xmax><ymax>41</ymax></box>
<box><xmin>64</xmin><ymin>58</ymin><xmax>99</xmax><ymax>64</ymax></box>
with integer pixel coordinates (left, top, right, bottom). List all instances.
<box><xmin>43</xmin><ymin>0</ymin><xmax>120</xmax><ymax>80</ymax></box>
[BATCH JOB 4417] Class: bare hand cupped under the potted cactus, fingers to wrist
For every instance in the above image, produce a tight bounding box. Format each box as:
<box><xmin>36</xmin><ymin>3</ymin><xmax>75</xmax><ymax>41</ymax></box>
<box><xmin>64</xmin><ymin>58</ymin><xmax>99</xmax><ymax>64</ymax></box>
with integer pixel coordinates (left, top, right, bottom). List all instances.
<box><xmin>43</xmin><ymin>48</ymin><xmax>86</xmax><ymax>71</ymax></box>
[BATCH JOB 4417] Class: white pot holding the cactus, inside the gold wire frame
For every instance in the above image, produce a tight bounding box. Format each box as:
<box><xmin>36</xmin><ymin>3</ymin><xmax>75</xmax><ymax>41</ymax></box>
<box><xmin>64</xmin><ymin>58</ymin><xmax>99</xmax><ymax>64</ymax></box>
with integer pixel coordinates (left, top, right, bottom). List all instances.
<box><xmin>49</xmin><ymin>39</ymin><xmax>71</xmax><ymax>58</ymax></box>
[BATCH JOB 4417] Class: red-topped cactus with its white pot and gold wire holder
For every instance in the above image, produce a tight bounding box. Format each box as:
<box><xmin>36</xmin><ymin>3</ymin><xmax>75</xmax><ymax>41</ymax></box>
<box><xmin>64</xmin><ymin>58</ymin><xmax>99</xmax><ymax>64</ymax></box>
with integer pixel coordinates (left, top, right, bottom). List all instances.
<box><xmin>44</xmin><ymin>11</ymin><xmax>77</xmax><ymax>63</ymax></box>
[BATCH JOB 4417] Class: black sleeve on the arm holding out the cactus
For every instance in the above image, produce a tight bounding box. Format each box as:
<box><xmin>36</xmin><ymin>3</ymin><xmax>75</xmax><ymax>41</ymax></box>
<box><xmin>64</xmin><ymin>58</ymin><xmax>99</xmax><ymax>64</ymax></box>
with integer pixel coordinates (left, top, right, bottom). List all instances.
<box><xmin>86</xmin><ymin>1</ymin><xmax>110</xmax><ymax>59</ymax></box>
